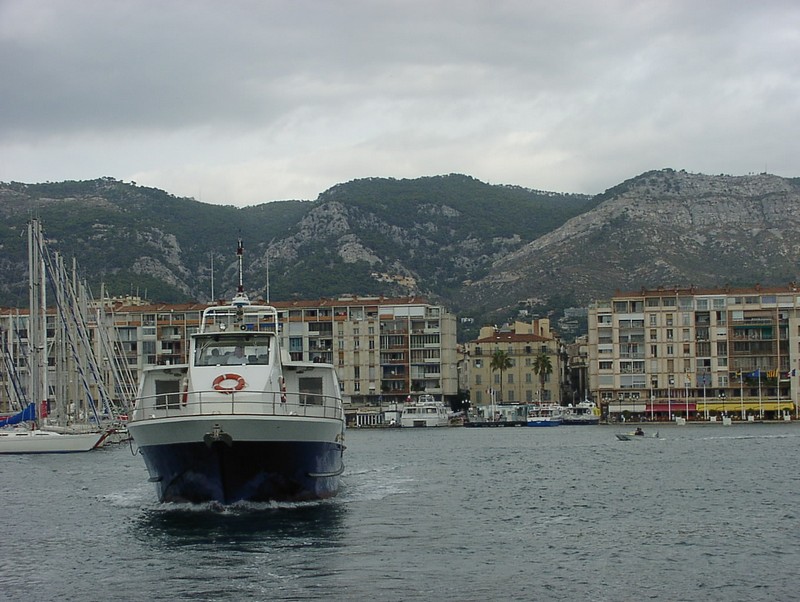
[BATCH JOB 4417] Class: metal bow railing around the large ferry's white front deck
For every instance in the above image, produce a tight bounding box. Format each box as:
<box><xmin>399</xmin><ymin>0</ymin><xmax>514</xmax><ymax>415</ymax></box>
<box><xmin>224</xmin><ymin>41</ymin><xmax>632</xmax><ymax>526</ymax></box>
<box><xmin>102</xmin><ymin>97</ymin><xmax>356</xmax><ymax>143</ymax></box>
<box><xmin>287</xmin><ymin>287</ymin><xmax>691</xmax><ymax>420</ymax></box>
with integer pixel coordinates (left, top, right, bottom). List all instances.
<box><xmin>132</xmin><ymin>390</ymin><xmax>344</xmax><ymax>421</ymax></box>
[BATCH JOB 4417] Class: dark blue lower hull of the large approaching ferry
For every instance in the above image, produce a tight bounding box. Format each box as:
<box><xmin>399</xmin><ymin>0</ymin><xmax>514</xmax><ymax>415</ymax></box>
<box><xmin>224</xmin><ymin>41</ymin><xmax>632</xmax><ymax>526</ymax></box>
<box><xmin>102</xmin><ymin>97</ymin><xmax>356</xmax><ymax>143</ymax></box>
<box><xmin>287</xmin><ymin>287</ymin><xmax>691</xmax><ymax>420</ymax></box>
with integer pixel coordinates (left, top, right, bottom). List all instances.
<box><xmin>141</xmin><ymin>441</ymin><xmax>344</xmax><ymax>504</ymax></box>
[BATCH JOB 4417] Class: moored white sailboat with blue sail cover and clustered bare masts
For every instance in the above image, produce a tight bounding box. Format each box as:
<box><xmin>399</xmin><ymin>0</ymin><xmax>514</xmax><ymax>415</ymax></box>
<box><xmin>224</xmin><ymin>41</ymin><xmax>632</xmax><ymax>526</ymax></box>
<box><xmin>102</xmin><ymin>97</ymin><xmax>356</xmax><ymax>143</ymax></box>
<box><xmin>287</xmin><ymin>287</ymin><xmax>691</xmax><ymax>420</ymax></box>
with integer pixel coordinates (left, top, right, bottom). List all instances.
<box><xmin>0</xmin><ymin>219</ymin><xmax>119</xmax><ymax>454</ymax></box>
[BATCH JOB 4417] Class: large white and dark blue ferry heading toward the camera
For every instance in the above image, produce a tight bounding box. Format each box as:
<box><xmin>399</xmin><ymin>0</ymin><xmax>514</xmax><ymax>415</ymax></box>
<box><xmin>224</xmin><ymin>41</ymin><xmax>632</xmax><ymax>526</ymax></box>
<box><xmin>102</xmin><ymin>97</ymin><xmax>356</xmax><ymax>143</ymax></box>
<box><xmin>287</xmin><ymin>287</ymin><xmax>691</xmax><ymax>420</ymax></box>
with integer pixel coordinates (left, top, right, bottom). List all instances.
<box><xmin>128</xmin><ymin>241</ymin><xmax>345</xmax><ymax>504</ymax></box>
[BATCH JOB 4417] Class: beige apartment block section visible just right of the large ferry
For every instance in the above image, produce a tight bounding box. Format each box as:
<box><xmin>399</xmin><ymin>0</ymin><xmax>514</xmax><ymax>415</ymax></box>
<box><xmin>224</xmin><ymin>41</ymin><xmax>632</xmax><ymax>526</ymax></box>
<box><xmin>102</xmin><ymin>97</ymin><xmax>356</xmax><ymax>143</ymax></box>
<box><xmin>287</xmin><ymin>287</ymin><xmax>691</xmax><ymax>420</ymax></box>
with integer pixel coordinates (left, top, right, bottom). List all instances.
<box><xmin>273</xmin><ymin>296</ymin><xmax>458</xmax><ymax>405</ymax></box>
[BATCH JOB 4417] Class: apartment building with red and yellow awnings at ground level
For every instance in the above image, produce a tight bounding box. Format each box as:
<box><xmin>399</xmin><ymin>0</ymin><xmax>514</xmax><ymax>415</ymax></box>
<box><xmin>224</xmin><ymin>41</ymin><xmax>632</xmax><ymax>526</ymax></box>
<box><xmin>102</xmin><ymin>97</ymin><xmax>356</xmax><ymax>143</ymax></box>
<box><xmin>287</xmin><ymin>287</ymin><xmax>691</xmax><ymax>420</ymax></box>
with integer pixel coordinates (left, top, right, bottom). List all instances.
<box><xmin>588</xmin><ymin>285</ymin><xmax>800</xmax><ymax>420</ymax></box>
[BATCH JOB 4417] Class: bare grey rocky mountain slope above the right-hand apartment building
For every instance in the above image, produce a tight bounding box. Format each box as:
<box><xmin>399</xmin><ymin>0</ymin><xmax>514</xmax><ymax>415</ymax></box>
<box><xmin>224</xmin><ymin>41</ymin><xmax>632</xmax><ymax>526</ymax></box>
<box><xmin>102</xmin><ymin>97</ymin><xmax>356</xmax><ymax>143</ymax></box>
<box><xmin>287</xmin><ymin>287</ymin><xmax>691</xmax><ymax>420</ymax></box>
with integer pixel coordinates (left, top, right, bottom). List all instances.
<box><xmin>467</xmin><ymin>169</ymin><xmax>800</xmax><ymax>304</ymax></box>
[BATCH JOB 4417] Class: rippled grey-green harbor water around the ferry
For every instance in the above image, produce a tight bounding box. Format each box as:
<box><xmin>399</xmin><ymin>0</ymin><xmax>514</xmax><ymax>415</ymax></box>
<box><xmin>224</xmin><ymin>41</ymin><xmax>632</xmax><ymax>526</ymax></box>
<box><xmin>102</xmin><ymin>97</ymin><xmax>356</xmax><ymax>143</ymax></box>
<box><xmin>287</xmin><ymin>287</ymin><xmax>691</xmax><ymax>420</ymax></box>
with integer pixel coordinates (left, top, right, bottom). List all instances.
<box><xmin>0</xmin><ymin>424</ymin><xmax>800</xmax><ymax>602</ymax></box>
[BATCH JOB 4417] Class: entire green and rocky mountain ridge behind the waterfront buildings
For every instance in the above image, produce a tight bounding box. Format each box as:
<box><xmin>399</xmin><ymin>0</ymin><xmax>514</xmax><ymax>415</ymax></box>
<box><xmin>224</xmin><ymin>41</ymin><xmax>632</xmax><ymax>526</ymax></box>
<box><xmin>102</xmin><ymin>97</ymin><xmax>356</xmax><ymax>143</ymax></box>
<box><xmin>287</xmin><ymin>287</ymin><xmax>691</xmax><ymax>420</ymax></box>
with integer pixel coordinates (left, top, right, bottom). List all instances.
<box><xmin>0</xmin><ymin>169</ymin><xmax>800</xmax><ymax>340</ymax></box>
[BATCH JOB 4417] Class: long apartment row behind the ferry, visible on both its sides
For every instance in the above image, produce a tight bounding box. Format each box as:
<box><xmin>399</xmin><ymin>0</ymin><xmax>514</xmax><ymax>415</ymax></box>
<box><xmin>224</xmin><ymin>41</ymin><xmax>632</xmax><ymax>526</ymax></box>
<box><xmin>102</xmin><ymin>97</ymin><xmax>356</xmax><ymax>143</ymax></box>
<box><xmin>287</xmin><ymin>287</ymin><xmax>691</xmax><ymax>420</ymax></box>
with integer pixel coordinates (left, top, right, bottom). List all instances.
<box><xmin>0</xmin><ymin>297</ymin><xmax>458</xmax><ymax>406</ymax></box>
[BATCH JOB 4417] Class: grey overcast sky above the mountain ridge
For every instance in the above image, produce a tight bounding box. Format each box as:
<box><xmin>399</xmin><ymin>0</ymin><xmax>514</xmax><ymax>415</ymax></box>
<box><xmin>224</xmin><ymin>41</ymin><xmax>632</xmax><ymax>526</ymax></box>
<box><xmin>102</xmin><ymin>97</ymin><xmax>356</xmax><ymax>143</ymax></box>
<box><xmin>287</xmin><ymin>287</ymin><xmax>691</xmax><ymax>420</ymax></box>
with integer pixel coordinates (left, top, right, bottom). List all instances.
<box><xmin>0</xmin><ymin>0</ymin><xmax>800</xmax><ymax>206</ymax></box>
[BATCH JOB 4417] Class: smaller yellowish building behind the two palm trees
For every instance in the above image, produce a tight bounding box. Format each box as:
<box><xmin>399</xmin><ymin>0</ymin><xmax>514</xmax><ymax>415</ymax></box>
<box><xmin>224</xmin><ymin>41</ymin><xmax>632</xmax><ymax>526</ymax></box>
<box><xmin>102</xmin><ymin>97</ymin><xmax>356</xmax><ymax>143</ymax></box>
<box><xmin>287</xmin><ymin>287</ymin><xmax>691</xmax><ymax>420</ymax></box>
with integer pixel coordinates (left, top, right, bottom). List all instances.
<box><xmin>461</xmin><ymin>319</ymin><xmax>565</xmax><ymax>406</ymax></box>
